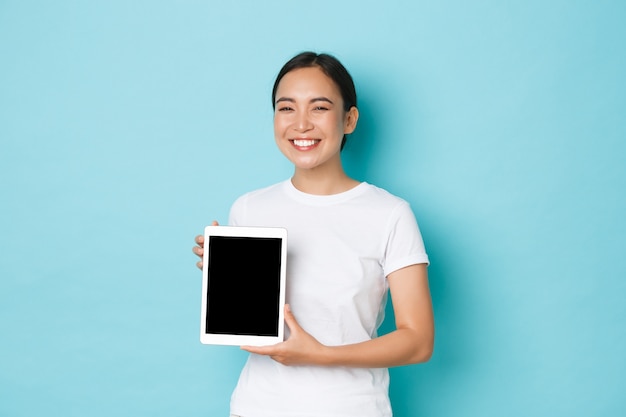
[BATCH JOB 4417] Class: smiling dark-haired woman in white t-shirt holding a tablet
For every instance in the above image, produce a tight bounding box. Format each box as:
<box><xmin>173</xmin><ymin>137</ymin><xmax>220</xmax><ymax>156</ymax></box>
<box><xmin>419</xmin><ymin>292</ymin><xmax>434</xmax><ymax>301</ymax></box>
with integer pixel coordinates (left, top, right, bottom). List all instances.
<box><xmin>193</xmin><ymin>52</ymin><xmax>434</xmax><ymax>417</ymax></box>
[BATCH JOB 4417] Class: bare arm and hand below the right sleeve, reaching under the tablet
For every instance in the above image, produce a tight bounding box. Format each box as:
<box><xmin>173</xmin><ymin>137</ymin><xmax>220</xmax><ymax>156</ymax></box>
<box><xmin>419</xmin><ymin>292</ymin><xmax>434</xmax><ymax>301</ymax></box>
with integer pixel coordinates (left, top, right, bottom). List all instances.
<box><xmin>242</xmin><ymin>264</ymin><xmax>434</xmax><ymax>368</ymax></box>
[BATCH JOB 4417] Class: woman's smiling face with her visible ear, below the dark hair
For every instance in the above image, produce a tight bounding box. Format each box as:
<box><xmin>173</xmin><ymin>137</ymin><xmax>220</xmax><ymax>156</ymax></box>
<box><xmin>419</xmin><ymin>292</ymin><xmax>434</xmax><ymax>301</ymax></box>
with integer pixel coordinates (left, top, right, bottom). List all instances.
<box><xmin>274</xmin><ymin>67</ymin><xmax>358</xmax><ymax>170</ymax></box>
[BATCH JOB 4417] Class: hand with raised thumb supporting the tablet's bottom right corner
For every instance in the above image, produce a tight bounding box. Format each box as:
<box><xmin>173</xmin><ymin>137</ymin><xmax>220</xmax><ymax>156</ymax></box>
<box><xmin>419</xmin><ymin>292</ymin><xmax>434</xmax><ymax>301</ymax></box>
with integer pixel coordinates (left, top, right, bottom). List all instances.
<box><xmin>241</xmin><ymin>304</ymin><xmax>326</xmax><ymax>365</ymax></box>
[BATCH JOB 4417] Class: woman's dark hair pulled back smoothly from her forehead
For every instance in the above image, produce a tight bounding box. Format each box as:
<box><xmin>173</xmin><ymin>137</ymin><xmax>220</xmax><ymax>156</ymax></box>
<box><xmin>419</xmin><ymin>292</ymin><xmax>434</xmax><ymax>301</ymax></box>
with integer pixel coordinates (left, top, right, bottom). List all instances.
<box><xmin>272</xmin><ymin>52</ymin><xmax>357</xmax><ymax>149</ymax></box>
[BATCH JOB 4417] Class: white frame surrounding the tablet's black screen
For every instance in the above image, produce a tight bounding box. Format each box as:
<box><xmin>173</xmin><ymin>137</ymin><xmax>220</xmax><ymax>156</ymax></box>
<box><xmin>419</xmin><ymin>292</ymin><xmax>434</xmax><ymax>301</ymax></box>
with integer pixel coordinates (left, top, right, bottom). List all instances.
<box><xmin>200</xmin><ymin>226</ymin><xmax>287</xmax><ymax>346</ymax></box>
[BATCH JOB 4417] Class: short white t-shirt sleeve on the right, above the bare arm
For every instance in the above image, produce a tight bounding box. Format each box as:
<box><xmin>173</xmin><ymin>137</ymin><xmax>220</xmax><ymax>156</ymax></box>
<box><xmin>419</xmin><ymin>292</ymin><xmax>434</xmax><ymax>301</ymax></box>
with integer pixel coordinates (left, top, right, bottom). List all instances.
<box><xmin>383</xmin><ymin>201</ymin><xmax>430</xmax><ymax>276</ymax></box>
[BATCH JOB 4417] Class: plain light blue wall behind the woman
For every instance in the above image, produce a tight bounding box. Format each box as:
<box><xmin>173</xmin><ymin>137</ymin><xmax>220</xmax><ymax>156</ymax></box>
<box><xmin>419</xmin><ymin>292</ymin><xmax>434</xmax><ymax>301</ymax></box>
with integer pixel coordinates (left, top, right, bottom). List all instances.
<box><xmin>0</xmin><ymin>0</ymin><xmax>626</xmax><ymax>417</ymax></box>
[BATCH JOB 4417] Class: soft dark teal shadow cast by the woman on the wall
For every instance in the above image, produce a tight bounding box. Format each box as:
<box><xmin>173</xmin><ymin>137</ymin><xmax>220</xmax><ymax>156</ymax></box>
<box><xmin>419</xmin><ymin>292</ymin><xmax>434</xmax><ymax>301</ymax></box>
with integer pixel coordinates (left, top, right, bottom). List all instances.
<box><xmin>343</xmin><ymin>66</ymin><xmax>486</xmax><ymax>417</ymax></box>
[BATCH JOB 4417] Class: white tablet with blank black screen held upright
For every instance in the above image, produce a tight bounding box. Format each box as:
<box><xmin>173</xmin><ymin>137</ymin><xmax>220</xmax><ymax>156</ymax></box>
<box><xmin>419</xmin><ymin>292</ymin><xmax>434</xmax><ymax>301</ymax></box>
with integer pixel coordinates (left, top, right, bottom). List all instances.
<box><xmin>200</xmin><ymin>226</ymin><xmax>287</xmax><ymax>346</ymax></box>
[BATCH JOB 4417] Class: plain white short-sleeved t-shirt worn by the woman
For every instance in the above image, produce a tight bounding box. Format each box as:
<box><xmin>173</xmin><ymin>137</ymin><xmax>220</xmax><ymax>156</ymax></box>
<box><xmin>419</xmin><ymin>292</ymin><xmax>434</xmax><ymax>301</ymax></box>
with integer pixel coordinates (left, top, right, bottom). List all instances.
<box><xmin>229</xmin><ymin>180</ymin><xmax>428</xmax><ymax>417</ymax></box>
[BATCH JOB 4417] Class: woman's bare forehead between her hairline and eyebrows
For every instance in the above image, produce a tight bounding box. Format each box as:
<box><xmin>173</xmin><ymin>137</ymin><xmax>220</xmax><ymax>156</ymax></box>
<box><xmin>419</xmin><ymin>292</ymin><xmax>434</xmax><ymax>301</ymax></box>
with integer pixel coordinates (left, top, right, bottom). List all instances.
<box><xmin>276</xmin><ymin>67</ymin><xmax>341</xmax><ymax>99</ymax></box>
